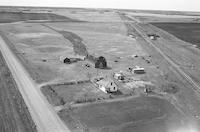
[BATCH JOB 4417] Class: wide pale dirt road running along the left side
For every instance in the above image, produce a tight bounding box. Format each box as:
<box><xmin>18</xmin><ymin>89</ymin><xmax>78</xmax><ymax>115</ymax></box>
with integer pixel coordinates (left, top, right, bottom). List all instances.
<box><xmin>0</xmin><ymin>36</ymin><xmax>69</xmax><ymax>132</ymax></box>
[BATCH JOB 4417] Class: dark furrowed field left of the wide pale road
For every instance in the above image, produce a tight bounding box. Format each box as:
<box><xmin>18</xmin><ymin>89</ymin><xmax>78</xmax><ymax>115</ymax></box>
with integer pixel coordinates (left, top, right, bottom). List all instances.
<box><xmin>0</xmin><ymin>48</ymin><xmax>37</xmax><ymax>132</ymax></box>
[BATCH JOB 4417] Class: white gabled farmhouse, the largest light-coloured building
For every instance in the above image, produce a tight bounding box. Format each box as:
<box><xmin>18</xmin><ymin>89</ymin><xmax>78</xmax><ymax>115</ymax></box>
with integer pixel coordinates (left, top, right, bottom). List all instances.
<box><xmin>96</xmin><ymin>79</ymin><xmax>118</xmax><ymax>93</ymax></box>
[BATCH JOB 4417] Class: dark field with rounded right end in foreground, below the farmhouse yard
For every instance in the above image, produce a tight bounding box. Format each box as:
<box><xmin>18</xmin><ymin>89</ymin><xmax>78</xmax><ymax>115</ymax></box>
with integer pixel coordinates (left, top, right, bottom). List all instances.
<box><xmin>59</xmin><ymin>97</ymin><xmax>188</xmax><ymax>132</ymax></box>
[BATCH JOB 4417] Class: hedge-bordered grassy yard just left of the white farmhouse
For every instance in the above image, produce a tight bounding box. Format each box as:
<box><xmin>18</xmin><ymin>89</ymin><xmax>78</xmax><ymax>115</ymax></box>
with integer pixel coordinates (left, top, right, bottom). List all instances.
<box><xmin>41</xmin><ymin>82</ymin><xmax>109</xmax><ymax>106</ymax></box>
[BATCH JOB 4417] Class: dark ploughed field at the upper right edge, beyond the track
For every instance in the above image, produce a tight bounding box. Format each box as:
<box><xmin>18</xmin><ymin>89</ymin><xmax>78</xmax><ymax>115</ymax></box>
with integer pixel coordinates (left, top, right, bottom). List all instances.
<box><xmin>151</xmin><ymin>23</ymin><xmax>200</xmax><ymax>47</ymax></box>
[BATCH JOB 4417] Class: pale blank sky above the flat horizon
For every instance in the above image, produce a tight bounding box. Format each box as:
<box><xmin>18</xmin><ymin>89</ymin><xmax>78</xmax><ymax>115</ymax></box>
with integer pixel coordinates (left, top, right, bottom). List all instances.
<box><xmin>0</xmin><ymin>0</ymin><xmax>200</xmax><ymax>11</ymax></box>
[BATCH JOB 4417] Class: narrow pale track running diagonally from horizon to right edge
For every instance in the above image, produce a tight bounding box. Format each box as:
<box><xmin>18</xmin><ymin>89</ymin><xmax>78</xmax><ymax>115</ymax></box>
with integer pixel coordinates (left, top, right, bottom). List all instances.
<box><xmin>120</xmin><ymin>16</ymin><xmax>200</xmax><ymax>94</ymax></box>
